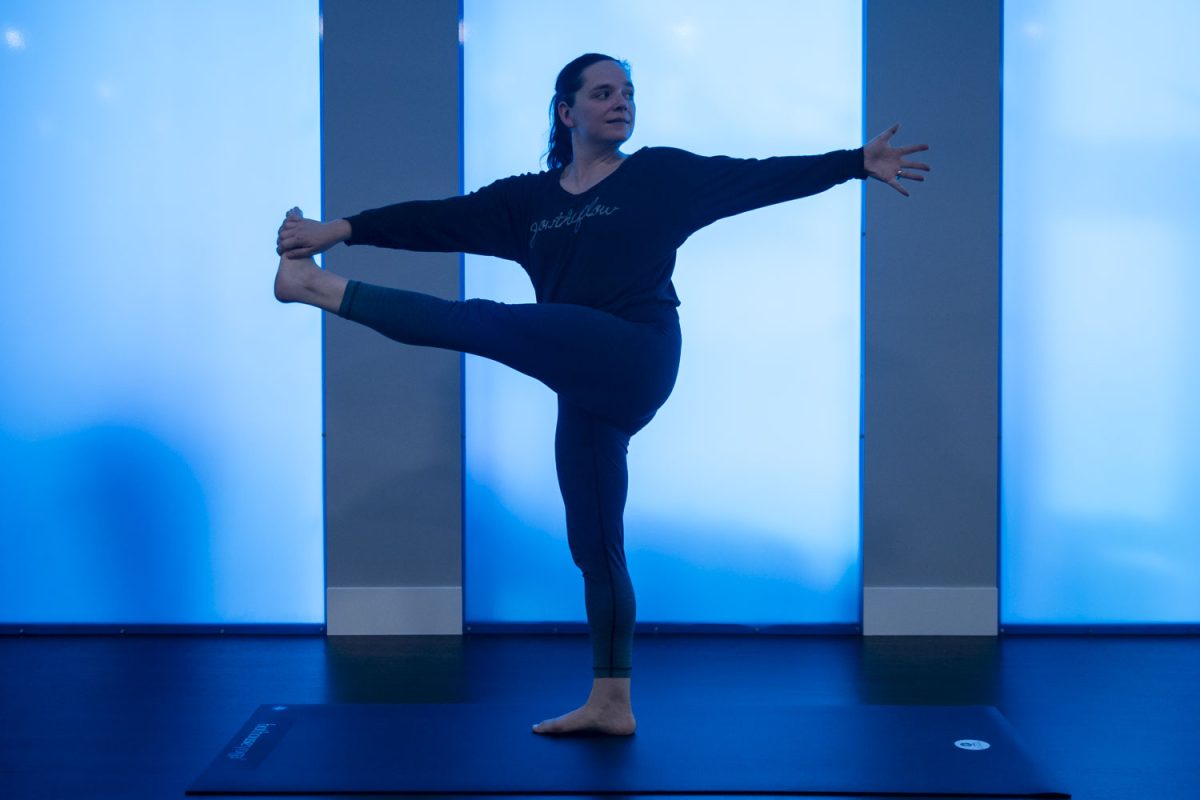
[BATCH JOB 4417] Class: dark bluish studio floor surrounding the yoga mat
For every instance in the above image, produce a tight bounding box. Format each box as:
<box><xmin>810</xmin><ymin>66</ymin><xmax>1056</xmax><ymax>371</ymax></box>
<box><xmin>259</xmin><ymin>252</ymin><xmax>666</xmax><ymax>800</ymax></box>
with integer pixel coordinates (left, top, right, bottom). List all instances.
<box><xmin>0</xmin><ymin>634</ymin><xmax>1200</xmax><ymax>800</ymax></box>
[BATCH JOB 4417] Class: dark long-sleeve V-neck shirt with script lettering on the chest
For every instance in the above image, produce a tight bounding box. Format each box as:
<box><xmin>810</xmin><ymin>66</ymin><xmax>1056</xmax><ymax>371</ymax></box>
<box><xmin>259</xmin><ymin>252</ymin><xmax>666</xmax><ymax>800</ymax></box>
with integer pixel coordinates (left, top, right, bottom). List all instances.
<box><xmin>347</xmin><ymin>148</ymin><xmax>866</xmax><ymax>319</ymax></box>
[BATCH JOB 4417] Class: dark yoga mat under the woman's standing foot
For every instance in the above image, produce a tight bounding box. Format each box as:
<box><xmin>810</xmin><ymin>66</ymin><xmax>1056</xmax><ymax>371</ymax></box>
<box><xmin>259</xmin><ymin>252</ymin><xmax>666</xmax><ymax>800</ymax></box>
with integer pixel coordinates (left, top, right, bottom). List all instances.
<box><xmin>187</xmin><ymin>702</ymin><xmax>1070</xmax><ymax>798</ymax></box>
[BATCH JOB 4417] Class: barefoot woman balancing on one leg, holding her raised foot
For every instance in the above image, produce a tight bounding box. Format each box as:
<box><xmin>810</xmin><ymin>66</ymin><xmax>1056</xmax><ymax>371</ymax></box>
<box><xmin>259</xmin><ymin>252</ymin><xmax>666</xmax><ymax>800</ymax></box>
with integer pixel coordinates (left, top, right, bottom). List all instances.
<box><xmin>275</xmin><ymin>53</ymin><xmax>929</xmax><ymax>735</ymax></box>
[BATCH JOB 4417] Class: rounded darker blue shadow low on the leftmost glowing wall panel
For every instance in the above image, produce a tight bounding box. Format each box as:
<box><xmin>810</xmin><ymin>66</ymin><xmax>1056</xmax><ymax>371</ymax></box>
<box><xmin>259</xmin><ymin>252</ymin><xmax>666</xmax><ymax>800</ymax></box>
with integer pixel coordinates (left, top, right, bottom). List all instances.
<box><xmin>0</xmin><ymin>425</ymin><xmax>214</xmax><ymax>624</ymax></box>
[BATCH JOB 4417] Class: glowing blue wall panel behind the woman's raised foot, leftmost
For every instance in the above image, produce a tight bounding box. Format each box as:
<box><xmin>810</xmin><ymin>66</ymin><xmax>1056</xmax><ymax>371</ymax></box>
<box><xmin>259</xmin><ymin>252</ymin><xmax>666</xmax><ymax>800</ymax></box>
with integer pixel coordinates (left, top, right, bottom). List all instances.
<box><xmin>0</xmin><ymin>0</ymin><xmax>324</xmax><ymax>624</ymax></box>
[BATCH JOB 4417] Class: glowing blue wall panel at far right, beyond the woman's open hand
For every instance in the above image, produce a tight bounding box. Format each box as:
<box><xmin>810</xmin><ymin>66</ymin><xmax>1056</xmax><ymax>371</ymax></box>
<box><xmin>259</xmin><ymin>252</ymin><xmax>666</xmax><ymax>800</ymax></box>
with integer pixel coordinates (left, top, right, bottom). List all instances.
<box><xmin>1001</xmin><ymin>0</ymin><xmax>1200</xmax><ymax>624</ymax></box>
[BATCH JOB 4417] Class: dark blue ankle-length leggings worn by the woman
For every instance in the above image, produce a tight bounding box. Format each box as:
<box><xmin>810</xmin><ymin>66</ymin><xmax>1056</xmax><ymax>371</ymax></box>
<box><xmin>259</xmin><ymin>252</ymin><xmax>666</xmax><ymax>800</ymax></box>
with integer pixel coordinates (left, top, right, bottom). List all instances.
<box><xmin>337</xmin><ymin>281</ymin><xmax>680</xmax><ymax>678</ymax></box>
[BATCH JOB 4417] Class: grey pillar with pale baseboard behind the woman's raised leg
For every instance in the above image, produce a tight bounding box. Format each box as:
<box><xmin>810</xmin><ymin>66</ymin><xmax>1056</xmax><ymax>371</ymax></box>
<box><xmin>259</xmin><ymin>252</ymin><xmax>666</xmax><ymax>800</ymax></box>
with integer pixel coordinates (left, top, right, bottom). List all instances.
<box><xmin>322</xmin><ymin>0</ymin><xmax>462</xmax><ymax>634</ymax></box>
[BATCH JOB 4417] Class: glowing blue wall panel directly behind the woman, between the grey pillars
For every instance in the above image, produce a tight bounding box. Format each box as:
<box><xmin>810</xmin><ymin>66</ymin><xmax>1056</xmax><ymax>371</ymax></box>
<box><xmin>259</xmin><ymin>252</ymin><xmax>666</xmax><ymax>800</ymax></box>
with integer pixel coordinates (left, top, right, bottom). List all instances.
<box><xmin>464</xmin><ymin>0</ymin><xmax>863</xmax><ymax>625</ymax></box>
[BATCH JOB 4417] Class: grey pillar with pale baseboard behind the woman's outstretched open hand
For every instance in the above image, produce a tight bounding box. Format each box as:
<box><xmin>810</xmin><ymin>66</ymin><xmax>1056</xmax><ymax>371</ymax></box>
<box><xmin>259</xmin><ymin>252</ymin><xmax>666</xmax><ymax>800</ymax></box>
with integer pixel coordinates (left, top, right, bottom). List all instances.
<box><xmin>863</xmin><ymin>0</ymin><xmax>1003</xmax><ymax>634</ymax></box>
